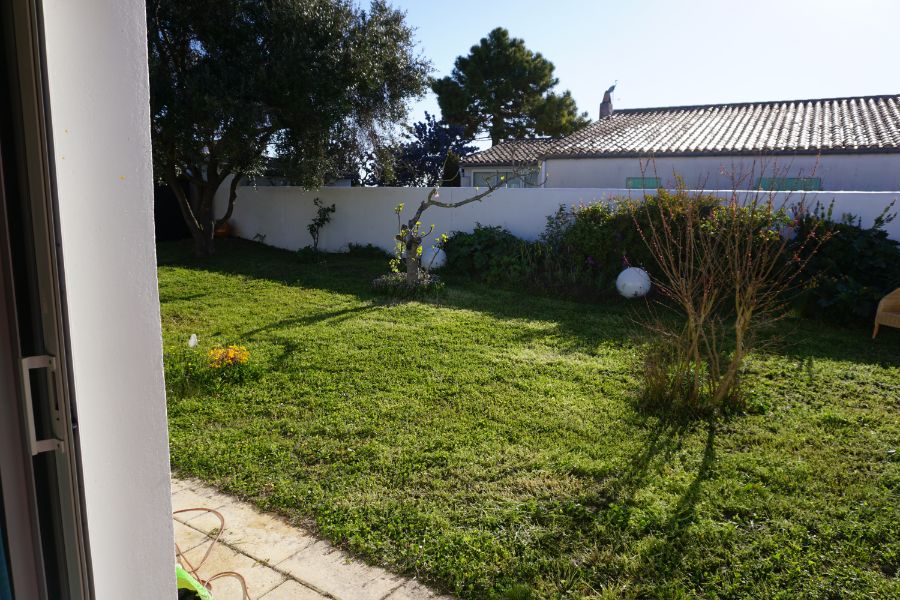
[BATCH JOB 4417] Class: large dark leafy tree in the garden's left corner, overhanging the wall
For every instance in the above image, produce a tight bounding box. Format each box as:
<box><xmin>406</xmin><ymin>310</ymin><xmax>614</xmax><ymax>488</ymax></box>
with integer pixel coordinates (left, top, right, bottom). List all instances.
<box><xmin>147</xmin><ymin>0</ymin><xmax>430</xmax><ymax>254</ymax></box>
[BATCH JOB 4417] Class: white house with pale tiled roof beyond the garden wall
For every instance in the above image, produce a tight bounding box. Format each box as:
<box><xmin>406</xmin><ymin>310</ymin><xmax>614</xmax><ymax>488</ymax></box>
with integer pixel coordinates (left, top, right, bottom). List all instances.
<box><xmin>461</xmin><ymin>94</ymin><xmax>900</xmax><ymax>191</ymax></box>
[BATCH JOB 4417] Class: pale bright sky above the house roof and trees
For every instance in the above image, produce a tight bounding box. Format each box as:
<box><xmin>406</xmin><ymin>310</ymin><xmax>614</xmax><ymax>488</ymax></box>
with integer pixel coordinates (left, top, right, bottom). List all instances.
<box><xmin>391</xmin><ymin>0</ymin><xmax>900</xmax><ymax>138</ymax></box>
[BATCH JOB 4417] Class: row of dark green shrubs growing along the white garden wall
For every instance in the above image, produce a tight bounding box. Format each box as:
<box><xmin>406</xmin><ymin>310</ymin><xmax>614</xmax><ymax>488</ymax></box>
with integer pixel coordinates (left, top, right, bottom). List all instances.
<box><xmin>443</xmin><ymin>195</ymin><xmax>900</xmax><ymax>322</ymax></box>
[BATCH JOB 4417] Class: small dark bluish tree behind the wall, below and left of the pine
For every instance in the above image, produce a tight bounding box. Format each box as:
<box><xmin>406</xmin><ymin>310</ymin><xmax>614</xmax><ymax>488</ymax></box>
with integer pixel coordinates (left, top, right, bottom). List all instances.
<box><xmin>366</xmin><ymin>112</ymin><xmax>478</xmax><ymax>187</ymax></box>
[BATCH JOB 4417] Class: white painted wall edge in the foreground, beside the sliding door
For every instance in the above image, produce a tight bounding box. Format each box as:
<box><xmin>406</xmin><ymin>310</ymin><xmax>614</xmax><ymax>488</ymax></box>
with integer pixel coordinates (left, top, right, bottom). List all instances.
<box><xmin>44</xmin><ymin>0</ymin><xmax>176</xmax><ymax>600</ymax></box>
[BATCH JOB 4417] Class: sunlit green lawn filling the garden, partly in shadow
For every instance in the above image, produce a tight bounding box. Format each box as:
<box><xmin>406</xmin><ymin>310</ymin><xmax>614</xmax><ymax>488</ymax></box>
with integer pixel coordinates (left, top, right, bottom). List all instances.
<box><xmin>159</xmin><ymin>241</ymin><xmax>900</xmax><ymax>598</ymax></box>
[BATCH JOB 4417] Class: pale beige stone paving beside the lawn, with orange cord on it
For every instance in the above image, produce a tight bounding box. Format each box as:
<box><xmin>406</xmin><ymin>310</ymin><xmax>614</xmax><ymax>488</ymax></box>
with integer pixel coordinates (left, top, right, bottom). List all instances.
<box><xmin>172</xmin><ymin>478</ymin><xmax>452</xmax><ymax>600</ymax></box>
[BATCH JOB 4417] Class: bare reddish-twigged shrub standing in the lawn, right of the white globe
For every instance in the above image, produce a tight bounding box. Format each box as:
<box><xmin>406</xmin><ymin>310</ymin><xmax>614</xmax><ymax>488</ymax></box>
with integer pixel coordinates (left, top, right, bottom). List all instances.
<box><xmin>630</xmin><ymin>176</ymin><xmax>830</xmax><ymax>413</ymax></box>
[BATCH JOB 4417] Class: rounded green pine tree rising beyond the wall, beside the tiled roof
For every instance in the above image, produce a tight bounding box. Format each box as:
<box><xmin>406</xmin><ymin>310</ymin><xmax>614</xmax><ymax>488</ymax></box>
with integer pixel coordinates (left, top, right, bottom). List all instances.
<box><xmin>431</xmin><ymin>27</ymin><xmax>590</xmax><ymax>144</ymax></box>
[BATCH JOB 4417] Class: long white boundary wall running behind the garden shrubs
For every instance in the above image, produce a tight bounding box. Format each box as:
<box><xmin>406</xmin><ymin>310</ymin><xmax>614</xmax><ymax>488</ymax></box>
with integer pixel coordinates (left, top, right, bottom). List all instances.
<box><xmin>217</xmin><ymin>182</ymin><xmax>900</xmax><ymax>262</ymax></box>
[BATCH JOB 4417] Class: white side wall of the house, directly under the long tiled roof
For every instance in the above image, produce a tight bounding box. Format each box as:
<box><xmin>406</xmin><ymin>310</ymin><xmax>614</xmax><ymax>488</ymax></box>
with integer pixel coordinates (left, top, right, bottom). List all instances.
<box><xmin>545</xmin><ymin>153</ymin><xmax>900</xmax><ymax>191</ymax></box>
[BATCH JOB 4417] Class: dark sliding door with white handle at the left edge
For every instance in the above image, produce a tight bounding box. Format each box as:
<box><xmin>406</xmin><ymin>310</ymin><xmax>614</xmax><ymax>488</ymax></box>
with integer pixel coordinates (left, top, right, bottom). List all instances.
<box><xmin>0</xmin><ymin>0</ymin><xmax>90</xmax><ymax>600</ymax></box>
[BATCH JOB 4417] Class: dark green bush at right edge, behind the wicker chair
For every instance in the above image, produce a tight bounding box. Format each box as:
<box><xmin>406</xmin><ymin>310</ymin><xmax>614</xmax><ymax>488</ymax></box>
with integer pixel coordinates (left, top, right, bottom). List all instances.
<box><xmin>797</xmin><ymin>202</ymin><xmax>900</xmax><ymax>322</ymax></box>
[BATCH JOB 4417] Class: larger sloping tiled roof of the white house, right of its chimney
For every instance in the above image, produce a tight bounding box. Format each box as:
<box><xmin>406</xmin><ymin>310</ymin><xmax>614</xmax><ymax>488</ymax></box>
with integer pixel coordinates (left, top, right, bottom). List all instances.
<box><xmin>541</xmin><ymin>95</ymin><xmax>900</xmax><ymax>158</ymax></box>
